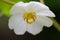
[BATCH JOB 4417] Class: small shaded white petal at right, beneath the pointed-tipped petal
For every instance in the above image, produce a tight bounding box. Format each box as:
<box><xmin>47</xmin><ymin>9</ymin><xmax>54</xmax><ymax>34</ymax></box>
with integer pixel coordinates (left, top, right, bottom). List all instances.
<box><xmin>37</xmin><ymin>16</ymin><xmax>53</xmax><ymax>27</ymax></box>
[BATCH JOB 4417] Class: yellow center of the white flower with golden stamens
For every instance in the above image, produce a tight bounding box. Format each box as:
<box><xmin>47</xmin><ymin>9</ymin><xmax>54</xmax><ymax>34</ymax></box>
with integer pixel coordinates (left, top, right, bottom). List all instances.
<box><xmin>23</xmin><ymin>12</ymin><xmax>36</xmax><ymax>24</ymax></box>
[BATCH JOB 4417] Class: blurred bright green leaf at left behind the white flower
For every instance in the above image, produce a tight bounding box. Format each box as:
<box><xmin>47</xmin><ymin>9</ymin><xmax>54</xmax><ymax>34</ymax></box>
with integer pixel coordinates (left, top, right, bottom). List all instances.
<box><xmin>0</xmin><ymin>2</ymin><xmax>12</xmax><ymax>17</ymax></box>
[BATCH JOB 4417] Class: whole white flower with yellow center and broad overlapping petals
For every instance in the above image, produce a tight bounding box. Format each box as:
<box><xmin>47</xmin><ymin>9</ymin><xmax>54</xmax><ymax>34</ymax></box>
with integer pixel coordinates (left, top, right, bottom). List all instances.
<box><xmin>8</xmin><ymin>1</ymin><xmax>55</xmax><ymax>35</ymax></box>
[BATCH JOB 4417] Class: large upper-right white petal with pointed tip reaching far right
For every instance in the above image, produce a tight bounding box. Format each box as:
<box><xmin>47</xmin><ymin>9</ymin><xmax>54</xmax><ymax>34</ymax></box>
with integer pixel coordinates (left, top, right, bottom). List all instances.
<box><xmin>27</xmin><ymin>1</ymin><xmax>55</xmax><ymax>17</ymax></box>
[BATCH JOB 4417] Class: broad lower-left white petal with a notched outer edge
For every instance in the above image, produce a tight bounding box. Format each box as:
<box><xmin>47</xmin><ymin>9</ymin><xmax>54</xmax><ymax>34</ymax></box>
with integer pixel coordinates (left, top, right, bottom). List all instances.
<box><xmin>9</xmin><ymin>16</ymin><xmax>26</xmax><ymax>35</ymax></box>
